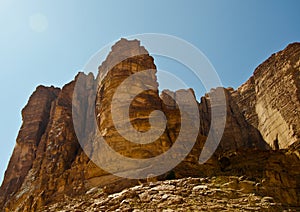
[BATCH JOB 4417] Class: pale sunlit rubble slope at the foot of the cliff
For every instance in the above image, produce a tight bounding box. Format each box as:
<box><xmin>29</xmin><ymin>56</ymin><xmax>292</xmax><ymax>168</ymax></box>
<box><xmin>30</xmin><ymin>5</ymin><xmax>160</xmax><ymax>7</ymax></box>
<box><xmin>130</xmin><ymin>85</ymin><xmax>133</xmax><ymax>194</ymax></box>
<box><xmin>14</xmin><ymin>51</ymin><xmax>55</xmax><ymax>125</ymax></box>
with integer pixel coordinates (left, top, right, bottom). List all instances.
<box><xmin>42</xmin><ymin>176</ymin><xmax>300</xmax><ymax>212</ymax></box>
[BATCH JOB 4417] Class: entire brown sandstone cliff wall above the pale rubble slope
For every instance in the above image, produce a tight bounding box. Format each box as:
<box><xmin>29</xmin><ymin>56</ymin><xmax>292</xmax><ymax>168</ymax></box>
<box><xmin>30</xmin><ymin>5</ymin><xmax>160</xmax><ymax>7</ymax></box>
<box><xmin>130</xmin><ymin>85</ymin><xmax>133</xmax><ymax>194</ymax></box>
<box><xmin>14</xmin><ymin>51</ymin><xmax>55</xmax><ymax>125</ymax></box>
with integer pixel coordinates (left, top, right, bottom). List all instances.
<box><xmin>0</xmin><ymin>39</ymin><xmax>300</xmax><ymax>211</ymax></box>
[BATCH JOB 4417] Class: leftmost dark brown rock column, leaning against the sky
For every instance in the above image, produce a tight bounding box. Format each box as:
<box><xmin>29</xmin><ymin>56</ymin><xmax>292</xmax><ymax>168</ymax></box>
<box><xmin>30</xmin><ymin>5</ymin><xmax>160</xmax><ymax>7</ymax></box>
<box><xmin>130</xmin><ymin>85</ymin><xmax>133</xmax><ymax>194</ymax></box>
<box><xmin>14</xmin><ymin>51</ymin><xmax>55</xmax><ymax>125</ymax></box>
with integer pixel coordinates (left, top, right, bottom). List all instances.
<box><xmin>0</xmin><ymin>86</ymin><xmax>60</xmax><ymax>207</ymax></box>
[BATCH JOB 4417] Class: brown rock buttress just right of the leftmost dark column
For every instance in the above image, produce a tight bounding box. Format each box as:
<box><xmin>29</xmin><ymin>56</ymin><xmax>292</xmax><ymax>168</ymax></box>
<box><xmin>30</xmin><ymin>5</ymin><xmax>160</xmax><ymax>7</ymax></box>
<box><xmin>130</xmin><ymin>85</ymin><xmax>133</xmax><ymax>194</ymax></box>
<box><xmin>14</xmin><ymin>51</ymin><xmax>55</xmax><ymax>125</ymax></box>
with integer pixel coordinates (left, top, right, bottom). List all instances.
<box><xmin>1</xmin><ymin>79</ymin><xmax>85</xmax><ymax>211</ymax></box>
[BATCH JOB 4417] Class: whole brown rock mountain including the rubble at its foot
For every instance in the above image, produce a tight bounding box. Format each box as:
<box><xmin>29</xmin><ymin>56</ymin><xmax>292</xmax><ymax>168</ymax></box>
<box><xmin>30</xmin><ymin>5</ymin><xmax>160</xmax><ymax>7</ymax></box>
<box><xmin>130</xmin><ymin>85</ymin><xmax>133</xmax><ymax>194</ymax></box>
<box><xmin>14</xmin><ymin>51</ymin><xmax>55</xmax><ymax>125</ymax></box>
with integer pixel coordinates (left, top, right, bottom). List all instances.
<box><xmin>0</xmin><ymin>39</ymin><xmax>300</xmax><ymax>211</ymax></box>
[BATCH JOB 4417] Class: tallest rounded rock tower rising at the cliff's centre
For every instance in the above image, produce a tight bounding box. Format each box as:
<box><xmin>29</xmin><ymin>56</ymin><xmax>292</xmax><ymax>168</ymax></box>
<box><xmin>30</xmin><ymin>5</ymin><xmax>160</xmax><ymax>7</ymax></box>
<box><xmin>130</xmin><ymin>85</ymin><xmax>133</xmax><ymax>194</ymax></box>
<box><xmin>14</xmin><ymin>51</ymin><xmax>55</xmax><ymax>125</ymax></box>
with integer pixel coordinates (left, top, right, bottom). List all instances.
<box><xmin>96</xmin><ymin>39</ymin><xmax>171</xmax><ymax>158</ymax></box>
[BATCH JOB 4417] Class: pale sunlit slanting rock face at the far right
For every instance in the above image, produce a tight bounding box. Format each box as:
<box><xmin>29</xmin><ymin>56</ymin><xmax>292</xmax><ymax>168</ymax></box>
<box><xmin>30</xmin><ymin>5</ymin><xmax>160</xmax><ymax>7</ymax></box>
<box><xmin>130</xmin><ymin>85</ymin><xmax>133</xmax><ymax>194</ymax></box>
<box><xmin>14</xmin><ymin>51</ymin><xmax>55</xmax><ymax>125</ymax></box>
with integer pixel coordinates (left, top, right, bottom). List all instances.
<box><xmin>234</xmin><ymin>43</ymin><xmax>300</xmax><ymax>149</ymax></box>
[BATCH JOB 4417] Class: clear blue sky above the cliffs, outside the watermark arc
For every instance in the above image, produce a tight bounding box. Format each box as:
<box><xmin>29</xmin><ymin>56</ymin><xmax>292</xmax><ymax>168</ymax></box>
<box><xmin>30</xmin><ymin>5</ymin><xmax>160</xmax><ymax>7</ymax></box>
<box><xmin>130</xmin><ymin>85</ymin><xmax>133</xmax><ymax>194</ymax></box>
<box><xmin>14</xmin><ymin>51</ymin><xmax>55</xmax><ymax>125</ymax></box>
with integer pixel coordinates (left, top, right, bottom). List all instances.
<box><xmin>0</xmin><ymin>0</ymin><xmax>300</xmax><ymax>182</ymax></box>
